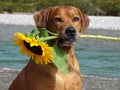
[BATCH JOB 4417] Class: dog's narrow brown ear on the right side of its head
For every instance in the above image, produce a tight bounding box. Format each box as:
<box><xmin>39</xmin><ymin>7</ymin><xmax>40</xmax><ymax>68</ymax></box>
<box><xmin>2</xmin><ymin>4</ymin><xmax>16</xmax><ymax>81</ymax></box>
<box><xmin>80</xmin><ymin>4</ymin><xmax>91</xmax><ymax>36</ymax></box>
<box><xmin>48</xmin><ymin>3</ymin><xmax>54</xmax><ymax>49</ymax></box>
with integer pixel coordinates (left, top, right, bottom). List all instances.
<box><xmin>78</xmin><ymin>10</ymin><xmax>90</xmax><ymax>34</ymax></box>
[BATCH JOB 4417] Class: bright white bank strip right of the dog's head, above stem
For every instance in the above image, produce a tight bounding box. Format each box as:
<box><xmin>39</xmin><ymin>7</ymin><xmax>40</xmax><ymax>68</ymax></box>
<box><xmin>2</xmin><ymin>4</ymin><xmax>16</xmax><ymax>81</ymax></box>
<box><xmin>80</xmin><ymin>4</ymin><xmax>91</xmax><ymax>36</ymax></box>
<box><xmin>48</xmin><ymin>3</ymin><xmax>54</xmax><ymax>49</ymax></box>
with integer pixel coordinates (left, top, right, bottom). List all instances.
<box><xmin>89</xmin><ymin>16</ymin><xmax>120</xmax><ymax>30</ymax></box>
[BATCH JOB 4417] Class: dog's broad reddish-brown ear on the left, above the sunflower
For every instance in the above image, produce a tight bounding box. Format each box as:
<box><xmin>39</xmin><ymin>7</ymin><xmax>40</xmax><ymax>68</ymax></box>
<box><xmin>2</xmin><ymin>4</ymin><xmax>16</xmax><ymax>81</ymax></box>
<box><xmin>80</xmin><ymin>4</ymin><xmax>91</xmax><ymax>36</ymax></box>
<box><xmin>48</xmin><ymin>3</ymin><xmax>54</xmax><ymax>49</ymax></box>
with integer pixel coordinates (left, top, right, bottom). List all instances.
<box><xmin>33</xmin><ymin>8</ymin><xmax>52</xmax><ymax>28</ymax></box>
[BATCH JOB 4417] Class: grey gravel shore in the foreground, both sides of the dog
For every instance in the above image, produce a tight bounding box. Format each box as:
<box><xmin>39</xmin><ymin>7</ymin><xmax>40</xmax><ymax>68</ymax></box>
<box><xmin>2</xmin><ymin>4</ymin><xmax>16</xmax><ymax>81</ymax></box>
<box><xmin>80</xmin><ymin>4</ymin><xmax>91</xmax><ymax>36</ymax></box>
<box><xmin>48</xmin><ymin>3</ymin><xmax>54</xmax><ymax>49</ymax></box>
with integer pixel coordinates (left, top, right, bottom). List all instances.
<box><xmin>0</xmin><ymin>68</ymin><xmax>120</xmax><ymax>90</ymax></box>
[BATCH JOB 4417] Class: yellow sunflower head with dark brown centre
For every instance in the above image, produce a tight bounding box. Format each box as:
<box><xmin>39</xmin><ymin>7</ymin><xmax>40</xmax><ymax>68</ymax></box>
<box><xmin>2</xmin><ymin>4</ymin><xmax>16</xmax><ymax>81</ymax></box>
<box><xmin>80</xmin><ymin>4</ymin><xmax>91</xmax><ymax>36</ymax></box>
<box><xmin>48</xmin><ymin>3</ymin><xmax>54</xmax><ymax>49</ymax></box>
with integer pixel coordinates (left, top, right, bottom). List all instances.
<box><xmin>14</xmin><ymin>33</ymin><xmax>54</xmax><ymax>64</ymax></box>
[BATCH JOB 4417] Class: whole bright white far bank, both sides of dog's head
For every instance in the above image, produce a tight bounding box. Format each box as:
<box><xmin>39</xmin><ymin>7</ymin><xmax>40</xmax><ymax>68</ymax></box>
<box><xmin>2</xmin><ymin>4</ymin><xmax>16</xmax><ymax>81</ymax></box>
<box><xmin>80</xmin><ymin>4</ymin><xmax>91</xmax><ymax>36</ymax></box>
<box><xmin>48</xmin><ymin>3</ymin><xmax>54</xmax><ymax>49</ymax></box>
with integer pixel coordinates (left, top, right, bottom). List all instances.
<box><xmin>0</xmin><ymin>14</ymin><xmax>120</xmax><ymax>30</ymax></box>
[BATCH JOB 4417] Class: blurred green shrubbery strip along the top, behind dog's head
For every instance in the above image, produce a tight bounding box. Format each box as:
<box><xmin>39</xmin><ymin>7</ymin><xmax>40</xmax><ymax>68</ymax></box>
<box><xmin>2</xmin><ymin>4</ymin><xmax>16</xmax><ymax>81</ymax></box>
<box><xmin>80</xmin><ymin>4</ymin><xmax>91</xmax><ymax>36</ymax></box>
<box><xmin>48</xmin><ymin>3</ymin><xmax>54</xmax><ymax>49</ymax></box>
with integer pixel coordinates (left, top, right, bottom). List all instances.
<box><xmin>0</xmin><ymin>0</ymin><xmax>120</xmax><ymax>16</ymax></box>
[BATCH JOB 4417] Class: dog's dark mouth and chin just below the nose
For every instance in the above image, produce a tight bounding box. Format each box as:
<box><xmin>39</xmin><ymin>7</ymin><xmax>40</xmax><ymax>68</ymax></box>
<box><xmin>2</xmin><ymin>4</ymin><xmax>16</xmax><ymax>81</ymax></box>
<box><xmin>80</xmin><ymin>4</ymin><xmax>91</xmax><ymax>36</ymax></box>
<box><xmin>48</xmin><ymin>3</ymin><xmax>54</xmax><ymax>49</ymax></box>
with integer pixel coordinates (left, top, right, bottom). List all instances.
<box><xmin>58</xmin><ymin>38</ymin><xmax>77</xmax><ymax>46</ymax></box>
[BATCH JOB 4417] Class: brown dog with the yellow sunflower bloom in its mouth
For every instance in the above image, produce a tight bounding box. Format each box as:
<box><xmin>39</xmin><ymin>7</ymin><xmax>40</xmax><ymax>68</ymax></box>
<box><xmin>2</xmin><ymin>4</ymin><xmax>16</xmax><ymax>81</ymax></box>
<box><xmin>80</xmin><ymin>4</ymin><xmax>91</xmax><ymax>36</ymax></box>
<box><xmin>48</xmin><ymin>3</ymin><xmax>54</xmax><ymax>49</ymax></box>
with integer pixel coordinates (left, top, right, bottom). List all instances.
<box><xmin>9</xmin><ymin>6</ymin><xmax>89</xmax><ymax>90</ymax></box>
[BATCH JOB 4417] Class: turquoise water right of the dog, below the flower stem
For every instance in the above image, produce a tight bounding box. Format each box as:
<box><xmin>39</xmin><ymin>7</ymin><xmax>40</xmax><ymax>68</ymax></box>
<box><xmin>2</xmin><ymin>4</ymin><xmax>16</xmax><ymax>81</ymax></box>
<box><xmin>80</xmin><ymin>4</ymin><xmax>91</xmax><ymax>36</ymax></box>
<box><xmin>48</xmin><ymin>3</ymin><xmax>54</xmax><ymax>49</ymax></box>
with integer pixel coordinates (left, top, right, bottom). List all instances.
<box><xmin>76</xmin><ymin>39</ymin><xmax>120</xmax><ymax>77</ymax></box>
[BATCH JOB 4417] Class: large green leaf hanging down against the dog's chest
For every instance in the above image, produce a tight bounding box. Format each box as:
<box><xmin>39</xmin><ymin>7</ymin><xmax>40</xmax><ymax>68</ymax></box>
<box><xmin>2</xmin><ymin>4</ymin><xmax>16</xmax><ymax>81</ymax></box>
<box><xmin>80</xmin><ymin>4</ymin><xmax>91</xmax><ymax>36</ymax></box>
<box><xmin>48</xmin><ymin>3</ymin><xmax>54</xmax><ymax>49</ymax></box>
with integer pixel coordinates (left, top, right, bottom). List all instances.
<box><xmin>52</xmin><ymin>43</ymin><xmax>69</xmax><ymax>73</ymax></box>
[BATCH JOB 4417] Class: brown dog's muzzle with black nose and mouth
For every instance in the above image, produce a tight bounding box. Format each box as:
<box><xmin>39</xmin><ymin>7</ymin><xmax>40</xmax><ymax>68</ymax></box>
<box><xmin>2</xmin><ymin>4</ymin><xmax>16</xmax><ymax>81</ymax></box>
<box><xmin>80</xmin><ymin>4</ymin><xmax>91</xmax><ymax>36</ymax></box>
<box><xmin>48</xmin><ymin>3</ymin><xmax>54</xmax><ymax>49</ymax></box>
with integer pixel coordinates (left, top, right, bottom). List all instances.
<box><xmin>59</xmin><ymin>26</ymin><xmax>77</xmax><ymax>46</ymax></box>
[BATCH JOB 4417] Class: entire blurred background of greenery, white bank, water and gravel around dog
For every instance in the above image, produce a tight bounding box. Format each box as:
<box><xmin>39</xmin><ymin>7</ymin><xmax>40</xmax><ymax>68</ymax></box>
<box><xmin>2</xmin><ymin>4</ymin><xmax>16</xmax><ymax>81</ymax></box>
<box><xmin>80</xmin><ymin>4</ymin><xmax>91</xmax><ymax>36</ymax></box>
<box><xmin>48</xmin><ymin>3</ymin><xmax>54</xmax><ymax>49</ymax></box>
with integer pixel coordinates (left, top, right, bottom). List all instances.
<box><xmin>0</xmin><ymin>0</ymin><xmax>120</xmax><ymax>90</ymax></box>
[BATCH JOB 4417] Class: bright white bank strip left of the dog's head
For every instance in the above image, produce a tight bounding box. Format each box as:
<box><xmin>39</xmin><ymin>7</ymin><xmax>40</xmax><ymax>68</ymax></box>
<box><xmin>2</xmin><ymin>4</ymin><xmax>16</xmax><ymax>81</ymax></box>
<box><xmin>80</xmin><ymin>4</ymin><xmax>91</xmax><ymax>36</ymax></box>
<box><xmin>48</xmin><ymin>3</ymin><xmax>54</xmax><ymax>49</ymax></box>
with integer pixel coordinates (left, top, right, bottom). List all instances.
<box><xmin>0</xmin><ymin>14</ymin><xmax>34</xmax><ymax>25</ymax></box>
